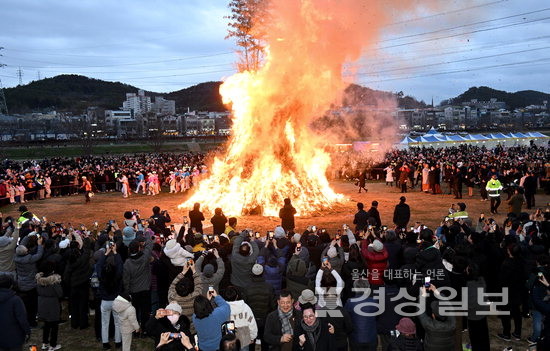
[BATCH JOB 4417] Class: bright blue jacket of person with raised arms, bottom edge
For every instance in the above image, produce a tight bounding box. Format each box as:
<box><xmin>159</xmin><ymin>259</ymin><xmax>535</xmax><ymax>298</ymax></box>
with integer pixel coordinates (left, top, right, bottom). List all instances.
<box><xmin>193</xmin><ymin>295</ymin><xmax>231</xmax><ymax>351</ymax></box>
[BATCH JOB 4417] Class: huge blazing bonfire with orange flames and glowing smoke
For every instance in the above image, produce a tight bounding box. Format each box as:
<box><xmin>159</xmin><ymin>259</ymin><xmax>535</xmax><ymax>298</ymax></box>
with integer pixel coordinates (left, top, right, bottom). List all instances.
<box><xmin>179</xmin><ymin>0</ymin><xmax>410</xmax><ymax>216</ymax></box>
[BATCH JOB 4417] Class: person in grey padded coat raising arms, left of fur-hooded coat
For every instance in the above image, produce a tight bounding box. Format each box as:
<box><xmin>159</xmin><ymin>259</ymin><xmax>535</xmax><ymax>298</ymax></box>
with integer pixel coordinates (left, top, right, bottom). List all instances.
<box><xmin>13</xmin><ymin>236</ymin><xmax>44</xmax><ymax>327</ymax></box>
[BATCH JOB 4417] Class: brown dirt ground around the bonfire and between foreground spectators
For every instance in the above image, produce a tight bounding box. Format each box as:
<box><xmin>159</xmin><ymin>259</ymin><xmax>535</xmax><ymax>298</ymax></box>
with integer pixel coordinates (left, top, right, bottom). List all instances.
<box><xmin>0</xmin><ymin>182</ymin><xmax>550</xmax><ymax>351</ymax></box>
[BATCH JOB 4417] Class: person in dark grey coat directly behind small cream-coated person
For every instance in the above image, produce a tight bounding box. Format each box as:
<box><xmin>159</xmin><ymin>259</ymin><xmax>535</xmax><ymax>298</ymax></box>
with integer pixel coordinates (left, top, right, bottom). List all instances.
<box><xmin>123</xmin><ymin>234</ymin><xmax>153</xmax><ymax>334</ymax></box>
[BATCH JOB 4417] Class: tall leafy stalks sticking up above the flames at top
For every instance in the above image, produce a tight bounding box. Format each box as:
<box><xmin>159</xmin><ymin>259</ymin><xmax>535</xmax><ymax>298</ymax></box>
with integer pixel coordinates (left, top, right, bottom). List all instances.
<box><xmin>225</xmin><ymin>0</ymin><xmax>267</xmax><ymax>71</ymax></box>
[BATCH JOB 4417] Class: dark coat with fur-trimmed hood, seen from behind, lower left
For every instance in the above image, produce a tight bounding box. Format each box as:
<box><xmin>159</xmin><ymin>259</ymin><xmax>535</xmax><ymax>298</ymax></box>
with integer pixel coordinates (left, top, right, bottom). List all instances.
<box><xmin>36</xmin><ymin>273</ymin><xmax>63</xmax><ymax>322</ymax></box>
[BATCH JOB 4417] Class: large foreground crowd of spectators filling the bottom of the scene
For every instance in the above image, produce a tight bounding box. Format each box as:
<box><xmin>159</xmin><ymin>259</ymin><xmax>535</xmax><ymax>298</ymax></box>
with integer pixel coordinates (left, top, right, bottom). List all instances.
<box><xmin>0</xmin><ymin>192</ymin><xmax>550</xmax><ymax>351</ymax></box>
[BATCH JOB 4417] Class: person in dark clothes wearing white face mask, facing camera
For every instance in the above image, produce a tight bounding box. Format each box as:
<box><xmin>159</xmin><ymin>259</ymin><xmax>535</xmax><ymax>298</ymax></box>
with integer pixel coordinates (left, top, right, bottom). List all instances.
<box><xmin>145</xmin><ymin>302</ymin><xmax>192</xmax><ymax>351</ymax></box>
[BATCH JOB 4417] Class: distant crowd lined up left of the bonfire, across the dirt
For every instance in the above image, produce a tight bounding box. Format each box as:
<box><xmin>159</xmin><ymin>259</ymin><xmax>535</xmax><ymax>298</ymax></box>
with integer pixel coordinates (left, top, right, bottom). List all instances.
<box><xmin>0</xmin><ymin>153</ymin><xmax>207</xmax><ymax>206</ymax></box>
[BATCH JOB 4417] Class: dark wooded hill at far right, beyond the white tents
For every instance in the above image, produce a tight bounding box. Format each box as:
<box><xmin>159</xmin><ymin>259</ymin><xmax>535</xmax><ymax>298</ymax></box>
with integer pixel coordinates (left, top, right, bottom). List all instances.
<box><xmin>441</xmin><ymin>86</ymin><xmax>550</xmax><ymax>110</ymax></box>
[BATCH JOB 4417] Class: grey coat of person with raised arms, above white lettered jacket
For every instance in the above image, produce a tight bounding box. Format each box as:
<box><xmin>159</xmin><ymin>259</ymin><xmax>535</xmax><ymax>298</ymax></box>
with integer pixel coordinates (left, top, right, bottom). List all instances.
<box><xmin>231</xmin><ymin>231</ymin><xmax>260</xmax><ymax>288</ymax></box>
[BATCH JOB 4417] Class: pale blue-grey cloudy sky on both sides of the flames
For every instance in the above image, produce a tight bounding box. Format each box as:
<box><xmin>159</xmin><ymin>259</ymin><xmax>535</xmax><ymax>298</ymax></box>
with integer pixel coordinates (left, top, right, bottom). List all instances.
<box><xmin>0</xmin><ymin>0</ymin><xmax>550</xmax><ymax>104</ymax></box>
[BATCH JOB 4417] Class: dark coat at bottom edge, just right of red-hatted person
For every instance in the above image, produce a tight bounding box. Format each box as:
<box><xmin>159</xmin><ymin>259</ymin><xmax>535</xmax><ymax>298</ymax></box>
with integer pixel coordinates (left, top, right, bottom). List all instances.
<box><xmin>418</xmin><ymin>313</ymin><xmax>456</xmax><ymax>351</ymax></box>
